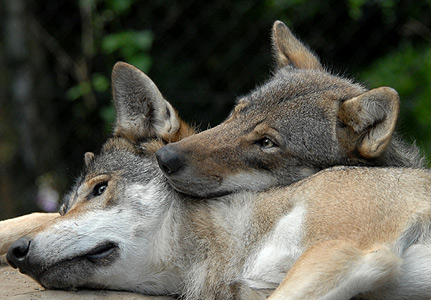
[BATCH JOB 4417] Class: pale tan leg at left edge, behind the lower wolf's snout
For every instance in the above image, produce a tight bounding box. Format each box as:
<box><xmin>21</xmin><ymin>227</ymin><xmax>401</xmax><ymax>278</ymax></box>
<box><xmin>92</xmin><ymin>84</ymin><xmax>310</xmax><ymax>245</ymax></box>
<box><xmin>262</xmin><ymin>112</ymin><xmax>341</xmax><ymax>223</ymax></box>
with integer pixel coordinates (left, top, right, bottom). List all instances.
<box><xmin>0</xmin><ymin>213</ymin><xmax>59</xmax><ymax>255</ymax></box>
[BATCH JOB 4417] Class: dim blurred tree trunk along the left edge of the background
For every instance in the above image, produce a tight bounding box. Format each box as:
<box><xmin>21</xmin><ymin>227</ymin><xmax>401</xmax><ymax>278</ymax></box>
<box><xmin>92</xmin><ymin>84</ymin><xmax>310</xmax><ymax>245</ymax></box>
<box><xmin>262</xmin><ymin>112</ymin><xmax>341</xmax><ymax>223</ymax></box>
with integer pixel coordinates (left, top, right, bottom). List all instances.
<box><xmin>0</xmin><ymin>0</ymin><xmax>58</xmax><ymax>218</ymax></box>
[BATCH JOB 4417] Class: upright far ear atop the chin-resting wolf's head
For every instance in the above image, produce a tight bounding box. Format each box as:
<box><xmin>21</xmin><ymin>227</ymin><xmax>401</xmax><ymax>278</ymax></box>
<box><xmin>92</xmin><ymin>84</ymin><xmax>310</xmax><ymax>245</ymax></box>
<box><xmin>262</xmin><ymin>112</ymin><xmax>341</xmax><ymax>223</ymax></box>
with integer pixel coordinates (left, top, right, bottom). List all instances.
<box><xmin>272</xmin><ymin>21</ymin><xmax>323</xmax><ymax>70</ymax></box>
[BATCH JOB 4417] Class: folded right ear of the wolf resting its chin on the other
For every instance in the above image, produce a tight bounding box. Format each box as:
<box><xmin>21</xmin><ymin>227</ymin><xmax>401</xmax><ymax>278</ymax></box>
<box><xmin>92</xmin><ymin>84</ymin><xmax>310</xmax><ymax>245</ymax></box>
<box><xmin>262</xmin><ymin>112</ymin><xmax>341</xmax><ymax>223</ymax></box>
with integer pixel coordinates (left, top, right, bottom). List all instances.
<box><xmin>338</xmin><ymin>87</ymin><xmax>400</xmax><ymax>158</ymax></box>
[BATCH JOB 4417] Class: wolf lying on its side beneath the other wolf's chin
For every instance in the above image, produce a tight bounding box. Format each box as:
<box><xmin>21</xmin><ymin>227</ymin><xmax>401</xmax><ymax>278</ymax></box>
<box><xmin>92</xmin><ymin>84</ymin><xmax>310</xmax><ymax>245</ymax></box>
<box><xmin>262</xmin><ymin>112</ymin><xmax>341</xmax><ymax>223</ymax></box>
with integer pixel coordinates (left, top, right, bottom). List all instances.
<box><xmin>7</xmin><ymin>63</ymin><xmax>431</xmax><ymax>300</ymax></box>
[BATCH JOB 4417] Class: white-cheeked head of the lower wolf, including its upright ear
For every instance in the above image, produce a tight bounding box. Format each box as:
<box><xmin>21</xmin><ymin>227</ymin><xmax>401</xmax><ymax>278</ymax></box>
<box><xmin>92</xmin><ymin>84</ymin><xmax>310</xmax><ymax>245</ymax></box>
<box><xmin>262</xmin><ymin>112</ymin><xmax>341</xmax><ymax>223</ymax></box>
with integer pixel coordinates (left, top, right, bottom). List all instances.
<box><xmin>7</xmin><ymin>63</ymin><xmax>192</xmax><ymax>294</ymax></box>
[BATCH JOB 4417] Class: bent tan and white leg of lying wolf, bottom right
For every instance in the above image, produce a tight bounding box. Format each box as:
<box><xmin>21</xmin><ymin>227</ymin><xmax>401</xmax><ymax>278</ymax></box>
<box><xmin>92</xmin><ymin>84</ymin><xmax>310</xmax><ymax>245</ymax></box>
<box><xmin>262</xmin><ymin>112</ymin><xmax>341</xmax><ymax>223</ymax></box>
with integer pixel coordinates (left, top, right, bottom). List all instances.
<box><xmin>269</xmin><ymin>240</ymin><xmax>401</xmax><ymax>300</ymax></box>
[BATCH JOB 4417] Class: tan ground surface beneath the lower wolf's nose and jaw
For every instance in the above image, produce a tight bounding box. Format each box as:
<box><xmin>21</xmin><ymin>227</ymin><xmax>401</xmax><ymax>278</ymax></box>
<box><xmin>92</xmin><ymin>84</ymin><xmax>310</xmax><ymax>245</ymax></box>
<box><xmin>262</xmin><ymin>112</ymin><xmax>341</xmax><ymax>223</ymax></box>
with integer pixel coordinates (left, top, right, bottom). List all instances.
<box><xmin>0</xmin><ymin>266</ymin><xmax>176</xmax><ymax>300</ymax></box>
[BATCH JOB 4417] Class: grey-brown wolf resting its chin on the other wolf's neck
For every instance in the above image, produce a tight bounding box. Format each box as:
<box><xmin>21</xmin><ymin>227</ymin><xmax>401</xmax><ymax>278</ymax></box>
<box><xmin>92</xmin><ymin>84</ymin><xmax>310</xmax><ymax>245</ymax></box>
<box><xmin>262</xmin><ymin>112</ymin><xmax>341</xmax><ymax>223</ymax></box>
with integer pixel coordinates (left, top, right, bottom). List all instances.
<box><xmin>156</xmin><ymin>21</ymin><xmax>425</xmax><ymax>197</ymax></box>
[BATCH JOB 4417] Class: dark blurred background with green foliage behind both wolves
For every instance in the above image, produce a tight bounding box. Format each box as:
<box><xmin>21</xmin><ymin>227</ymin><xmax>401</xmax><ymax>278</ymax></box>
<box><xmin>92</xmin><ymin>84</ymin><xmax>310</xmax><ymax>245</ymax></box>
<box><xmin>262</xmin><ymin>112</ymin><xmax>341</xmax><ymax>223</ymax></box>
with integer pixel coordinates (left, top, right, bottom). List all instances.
<box><xmin>0</xmin><ymin>0</ymin><xmax>431</xmax><ymax>219</ymax></box>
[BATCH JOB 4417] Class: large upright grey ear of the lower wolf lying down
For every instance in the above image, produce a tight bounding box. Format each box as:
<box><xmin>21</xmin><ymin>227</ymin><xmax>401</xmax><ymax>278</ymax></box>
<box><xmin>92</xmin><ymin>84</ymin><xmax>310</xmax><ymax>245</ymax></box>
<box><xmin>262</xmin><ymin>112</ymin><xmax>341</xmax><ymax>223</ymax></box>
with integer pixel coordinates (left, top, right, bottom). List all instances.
<box><xmin>112</xmin><ymin>62</ymin><xmax>190</xmax><ymax>142</ymax></box>
